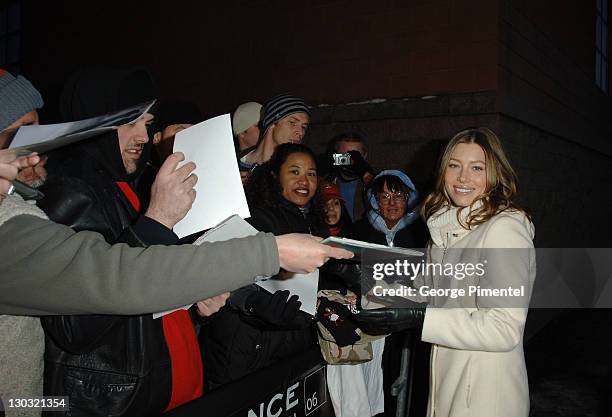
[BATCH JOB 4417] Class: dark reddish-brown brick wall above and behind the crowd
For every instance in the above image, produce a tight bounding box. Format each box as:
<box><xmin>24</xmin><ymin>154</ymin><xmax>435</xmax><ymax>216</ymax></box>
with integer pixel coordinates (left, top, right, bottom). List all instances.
<box><xmin>22</xmin><ymin>0</ymin><xmax>497</xmax><ymax>116</ymax></box>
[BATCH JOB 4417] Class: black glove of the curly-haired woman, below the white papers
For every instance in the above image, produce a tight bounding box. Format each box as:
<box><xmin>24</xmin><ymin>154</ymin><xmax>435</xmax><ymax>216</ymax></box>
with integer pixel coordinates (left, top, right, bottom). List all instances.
<box><xmin>246</xmin><ymin>290</ymin><xmax>302</xmax><ymax>327</ymax></box>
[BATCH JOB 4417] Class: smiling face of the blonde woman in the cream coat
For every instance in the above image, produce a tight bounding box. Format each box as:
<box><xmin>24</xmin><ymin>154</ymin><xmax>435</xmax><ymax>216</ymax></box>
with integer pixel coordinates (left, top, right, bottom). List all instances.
<box><xmin>444</xmin><ymin>143</ymin><xmax>487</xmax><ymax>207</ymax></box>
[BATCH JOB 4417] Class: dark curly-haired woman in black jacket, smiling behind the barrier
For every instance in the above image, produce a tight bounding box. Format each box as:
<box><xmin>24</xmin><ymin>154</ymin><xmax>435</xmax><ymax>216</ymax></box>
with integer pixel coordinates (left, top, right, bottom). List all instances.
<box><xmin>203</xmin><ymin>143</ymin><xmax>326</xmax><ymax>389</ymax></box>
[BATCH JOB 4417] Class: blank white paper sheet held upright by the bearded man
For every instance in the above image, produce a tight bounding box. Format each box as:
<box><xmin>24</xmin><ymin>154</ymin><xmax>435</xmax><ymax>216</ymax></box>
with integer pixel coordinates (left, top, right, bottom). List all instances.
<box><xmin>174</xmin><ymin>114</ymin><xmax>251</xmax><ymax>237</ymax></box>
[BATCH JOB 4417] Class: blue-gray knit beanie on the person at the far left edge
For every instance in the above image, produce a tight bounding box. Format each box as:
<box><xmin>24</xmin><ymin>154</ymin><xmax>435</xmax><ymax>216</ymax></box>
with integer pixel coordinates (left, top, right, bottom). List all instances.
<box><xmin>0</xmin><ymin>68</ymin><xmax>43</xmax><ymax>131</ymax></box>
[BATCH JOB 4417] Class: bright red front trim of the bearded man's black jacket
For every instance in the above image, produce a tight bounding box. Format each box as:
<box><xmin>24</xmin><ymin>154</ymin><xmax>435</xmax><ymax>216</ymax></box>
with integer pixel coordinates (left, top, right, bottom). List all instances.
<box><xmin>116</xmin><ymin>181</ymin><xmax>204</xmax><ymax>413</ymax></box>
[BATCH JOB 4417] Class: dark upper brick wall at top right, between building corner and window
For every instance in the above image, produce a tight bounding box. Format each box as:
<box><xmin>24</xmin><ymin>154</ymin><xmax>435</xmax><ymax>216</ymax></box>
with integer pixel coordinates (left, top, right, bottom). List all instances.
<box><xmin>499</xmin><ymin>0</ymin><xmax>612</xmax><ymax>156</ymax></box>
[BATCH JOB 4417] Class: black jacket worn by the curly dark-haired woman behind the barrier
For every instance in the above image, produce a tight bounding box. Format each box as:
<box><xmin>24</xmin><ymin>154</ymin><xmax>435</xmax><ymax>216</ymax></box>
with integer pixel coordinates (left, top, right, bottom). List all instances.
<box><xmin>200</xmin><ymin>200</ymin><xmax>326</xmax><ymax>389</ymax></box>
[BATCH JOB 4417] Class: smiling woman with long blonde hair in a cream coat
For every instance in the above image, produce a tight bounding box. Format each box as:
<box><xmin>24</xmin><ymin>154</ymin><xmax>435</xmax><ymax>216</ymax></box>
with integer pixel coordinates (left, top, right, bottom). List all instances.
<box><xmin>418</xmin><ymin>127</ymin><xmax>535</xmax><ymax>417</ymax></box>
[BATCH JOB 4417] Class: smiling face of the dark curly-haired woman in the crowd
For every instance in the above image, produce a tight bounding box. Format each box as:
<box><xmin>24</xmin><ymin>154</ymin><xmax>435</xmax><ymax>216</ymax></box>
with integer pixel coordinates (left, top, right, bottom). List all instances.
<box><xmin>279</xmin><ymin>152</ymin><xmax>317</xmax><ymax>207</ymax></box>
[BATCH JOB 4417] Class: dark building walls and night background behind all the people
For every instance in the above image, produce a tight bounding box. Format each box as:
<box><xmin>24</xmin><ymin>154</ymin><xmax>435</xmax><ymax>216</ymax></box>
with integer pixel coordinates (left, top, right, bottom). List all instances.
<box><xmin>0</xmin><ymin>0</ymin><xmax>612</xmax><ymax>417</ymax></box>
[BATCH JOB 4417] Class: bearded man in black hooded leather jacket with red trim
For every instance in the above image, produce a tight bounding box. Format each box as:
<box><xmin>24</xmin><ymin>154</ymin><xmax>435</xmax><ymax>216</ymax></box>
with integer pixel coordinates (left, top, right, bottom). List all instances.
<box><xmin>39</xmin><ymin>69</ymin><xmax>210</xmax><ymax>416</ymax></box>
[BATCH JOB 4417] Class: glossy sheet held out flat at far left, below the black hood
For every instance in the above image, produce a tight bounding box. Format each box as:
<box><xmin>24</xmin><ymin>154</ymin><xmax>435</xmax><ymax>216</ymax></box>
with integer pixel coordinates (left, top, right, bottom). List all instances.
<box><xmin>9</xmin><ymin>100</ymin><xmax>155</xmax><ymax>153</ymax></box>
